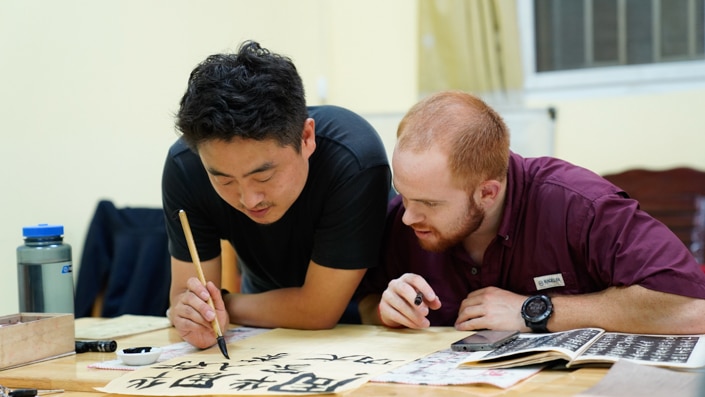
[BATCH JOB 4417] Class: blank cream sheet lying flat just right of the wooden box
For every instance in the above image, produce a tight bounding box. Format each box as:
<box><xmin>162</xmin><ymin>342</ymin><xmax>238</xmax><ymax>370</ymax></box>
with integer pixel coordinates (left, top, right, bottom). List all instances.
<box><xmin>75</xmin><ymin>314</ymin><xmax>171</xmax><ymax>339</ymax></box>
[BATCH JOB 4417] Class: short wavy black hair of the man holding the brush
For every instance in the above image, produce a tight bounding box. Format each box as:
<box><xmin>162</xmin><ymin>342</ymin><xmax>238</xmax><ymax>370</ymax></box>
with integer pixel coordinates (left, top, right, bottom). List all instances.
<box><xmin>176</xmin><ymin>41</ymin><xmax>308</xmax><ymax>152</ymax></box>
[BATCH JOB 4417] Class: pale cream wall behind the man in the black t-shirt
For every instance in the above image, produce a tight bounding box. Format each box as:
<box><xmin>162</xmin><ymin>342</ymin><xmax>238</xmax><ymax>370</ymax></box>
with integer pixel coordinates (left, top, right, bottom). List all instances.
<box><xmin>0</xmin><ymin>0</ymin><xmax>416</xmax><ymax>315</ymax></box>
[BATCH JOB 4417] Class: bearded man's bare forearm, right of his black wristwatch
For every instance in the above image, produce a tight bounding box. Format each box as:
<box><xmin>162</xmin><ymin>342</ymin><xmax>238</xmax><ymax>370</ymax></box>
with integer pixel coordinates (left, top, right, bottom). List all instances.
<box><xmin>548</xmin><ymin>286</ymin><xmax>705</xmax><ymax>334</ymax></box>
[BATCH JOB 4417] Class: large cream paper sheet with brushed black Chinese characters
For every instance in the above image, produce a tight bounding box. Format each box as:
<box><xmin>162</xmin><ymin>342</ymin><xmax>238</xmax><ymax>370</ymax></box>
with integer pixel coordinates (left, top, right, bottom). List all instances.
<box><xmin>97</xmin><ymin>325</ymin><xmax>466</xmax><ymax>396</ymax></box>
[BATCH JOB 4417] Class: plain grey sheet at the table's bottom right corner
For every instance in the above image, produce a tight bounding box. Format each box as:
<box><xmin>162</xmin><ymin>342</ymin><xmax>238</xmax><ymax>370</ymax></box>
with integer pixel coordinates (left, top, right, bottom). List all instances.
<box><xmin>575</xmin><ymin>360</ymin><xmax>705</xmax><ymax>397</ymax></box>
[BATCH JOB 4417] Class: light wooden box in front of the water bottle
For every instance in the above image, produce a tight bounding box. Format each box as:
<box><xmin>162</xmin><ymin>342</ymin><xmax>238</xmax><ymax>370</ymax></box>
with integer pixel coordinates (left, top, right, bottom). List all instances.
<box><xmin>0</xmin><ymin>313</ymin><xmax>76</xmax><ymax>370</ymax></box>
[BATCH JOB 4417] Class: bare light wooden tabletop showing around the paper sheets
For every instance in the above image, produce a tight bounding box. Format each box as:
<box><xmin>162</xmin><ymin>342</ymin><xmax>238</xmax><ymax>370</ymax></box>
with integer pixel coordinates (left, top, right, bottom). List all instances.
<box><xmin>0</xmin><ymin>322</ymin><xmax>607</xmax><ymax>397</ymax></box>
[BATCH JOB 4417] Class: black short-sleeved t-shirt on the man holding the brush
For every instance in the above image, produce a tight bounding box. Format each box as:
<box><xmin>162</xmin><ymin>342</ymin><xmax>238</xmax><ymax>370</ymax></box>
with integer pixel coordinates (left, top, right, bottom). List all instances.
<box><xmin>162</xmin><ymin>106</ymin><xmax>391</xmax><ymax>291</ymax></box>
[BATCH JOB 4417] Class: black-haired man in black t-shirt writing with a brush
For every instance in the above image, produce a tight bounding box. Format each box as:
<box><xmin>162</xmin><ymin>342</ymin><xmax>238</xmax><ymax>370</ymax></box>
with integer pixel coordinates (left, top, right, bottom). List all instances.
<box><xmin>162</xmin><ymin>41</ymin><xmax>391</xmax><ymax>348</ymax></box>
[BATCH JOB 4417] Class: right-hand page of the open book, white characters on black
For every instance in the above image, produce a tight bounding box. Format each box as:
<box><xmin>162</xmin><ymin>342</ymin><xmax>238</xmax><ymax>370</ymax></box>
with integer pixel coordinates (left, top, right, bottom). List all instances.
<box><xmin>569</xmin><ymin>332</ymin><xmax>705</xmax><ymax>369</ymax></box>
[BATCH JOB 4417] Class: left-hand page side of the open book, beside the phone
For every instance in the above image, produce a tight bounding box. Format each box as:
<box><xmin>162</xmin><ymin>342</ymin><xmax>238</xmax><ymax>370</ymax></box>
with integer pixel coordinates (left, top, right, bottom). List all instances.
<box><xmin>461</xmin><ymin>328</ymin><xmax>604</xmax><ymax>368</ymax></box>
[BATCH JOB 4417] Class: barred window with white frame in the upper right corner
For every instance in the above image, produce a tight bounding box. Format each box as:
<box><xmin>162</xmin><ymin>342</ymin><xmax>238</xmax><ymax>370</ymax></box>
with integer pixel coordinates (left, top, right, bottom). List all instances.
<box><xmin>517</xmin><ymin>0</ymin><xmax>705</xmax><ymax>95</ymax></box>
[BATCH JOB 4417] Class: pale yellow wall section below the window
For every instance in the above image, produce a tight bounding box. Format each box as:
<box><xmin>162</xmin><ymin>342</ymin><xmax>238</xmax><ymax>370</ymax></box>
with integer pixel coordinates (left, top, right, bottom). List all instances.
<box><xmin>528</xmin><ymin>88</ymin><xmax>705</xmax><ymax>174</ymax></box>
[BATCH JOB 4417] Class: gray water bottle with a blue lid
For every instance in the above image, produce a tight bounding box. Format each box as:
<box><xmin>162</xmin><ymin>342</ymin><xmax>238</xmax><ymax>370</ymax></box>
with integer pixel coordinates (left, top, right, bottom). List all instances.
<box><xmin>17</xmin><ymin>224</ymin><xmax>74</xmax><ymax>314</ymax></box>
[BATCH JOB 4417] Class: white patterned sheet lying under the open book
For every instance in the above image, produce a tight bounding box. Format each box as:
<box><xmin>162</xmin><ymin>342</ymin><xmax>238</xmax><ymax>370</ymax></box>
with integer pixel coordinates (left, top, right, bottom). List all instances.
<box><xmin>372</xmin><ymin>349</ymin><xmax>544</xmax><ymax>389</ymax></box>
